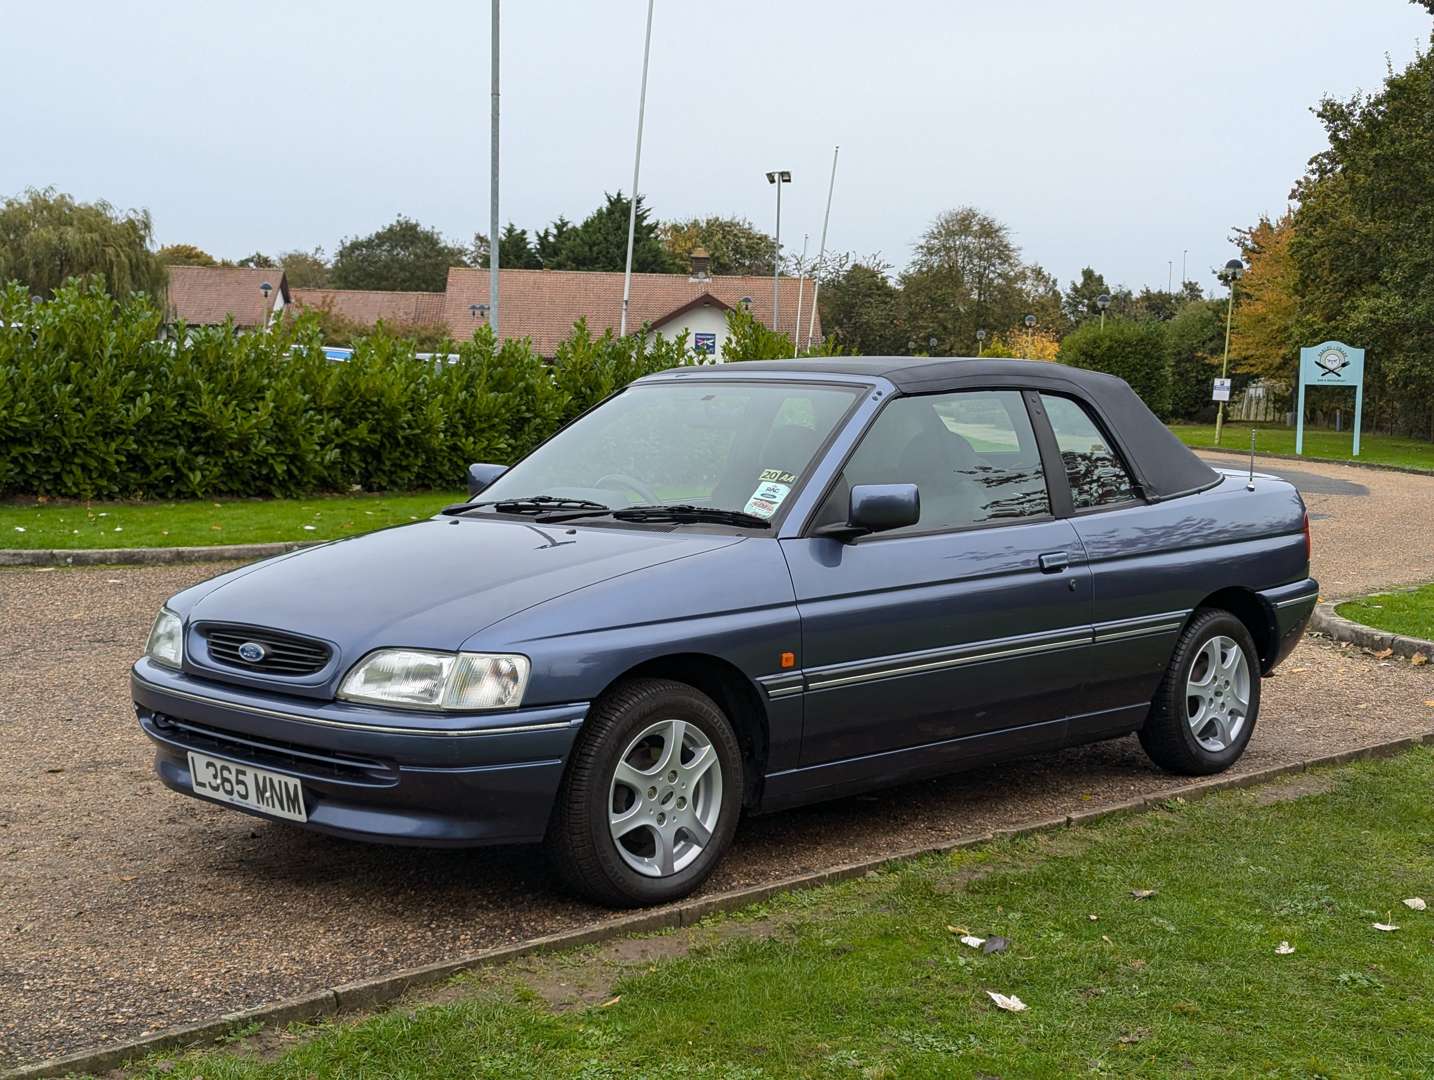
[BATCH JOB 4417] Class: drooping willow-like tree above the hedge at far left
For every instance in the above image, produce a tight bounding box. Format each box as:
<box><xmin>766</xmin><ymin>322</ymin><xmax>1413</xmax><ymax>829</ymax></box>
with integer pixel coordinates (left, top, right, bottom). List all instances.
<box><xmin>0</xmin><ymin>188</ymin><xmax>168</xmax><ymax>298</ymax></box>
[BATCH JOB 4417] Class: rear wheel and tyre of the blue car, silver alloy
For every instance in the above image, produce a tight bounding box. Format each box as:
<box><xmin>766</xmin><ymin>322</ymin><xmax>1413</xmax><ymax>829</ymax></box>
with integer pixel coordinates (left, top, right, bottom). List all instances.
<box><xmin>1140</xmin><ymin>608</ymin><xmax>1260</xmax><ymax>776</ymax></box>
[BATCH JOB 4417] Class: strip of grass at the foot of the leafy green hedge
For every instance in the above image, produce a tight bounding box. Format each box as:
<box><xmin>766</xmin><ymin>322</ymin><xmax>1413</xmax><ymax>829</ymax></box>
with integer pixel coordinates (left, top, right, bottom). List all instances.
<box><xmin>0</xmin><ymin>492</ymin><xmax>467</xmax><ymax>548</ymax></box>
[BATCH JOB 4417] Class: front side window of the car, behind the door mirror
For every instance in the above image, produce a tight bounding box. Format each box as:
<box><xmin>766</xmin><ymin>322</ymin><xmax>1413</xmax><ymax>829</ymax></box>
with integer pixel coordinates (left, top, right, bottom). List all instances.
<box><xmin>820</xmin><ymin>390</ymin><xmax>1051</xmax><ymax>535</ymax></box>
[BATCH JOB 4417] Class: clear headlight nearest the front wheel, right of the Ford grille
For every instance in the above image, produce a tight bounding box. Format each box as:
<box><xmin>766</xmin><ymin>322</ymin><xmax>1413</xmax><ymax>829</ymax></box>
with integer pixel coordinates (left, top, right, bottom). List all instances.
<box><xmin>338</xmin><ymin>648</ymin><xmax>529</xmax><ymax>710</ymax></box>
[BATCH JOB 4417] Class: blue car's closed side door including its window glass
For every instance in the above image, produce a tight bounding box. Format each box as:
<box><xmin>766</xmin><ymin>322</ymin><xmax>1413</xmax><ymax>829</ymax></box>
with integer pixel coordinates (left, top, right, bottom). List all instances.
<box><xmin>782</xmin><ymin>390</ymin><xmax>1091</xmax><ymax>766</ymax></box>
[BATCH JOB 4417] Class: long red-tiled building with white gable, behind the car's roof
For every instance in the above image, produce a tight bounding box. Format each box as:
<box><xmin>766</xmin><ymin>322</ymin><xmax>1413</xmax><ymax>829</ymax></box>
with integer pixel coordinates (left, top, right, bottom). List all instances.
<box><xmin>443</xmin><ymin>267</ymin><xmax>822</xmax><ymax>359</ymax></box>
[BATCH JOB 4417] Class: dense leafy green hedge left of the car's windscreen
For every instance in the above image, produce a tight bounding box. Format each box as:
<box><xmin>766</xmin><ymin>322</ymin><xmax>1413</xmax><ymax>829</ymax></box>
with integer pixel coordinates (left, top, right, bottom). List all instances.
<box><xmin>0</xmin><ymin>284</ymin><xmax>690</xmax><ymax>498</ymax></box>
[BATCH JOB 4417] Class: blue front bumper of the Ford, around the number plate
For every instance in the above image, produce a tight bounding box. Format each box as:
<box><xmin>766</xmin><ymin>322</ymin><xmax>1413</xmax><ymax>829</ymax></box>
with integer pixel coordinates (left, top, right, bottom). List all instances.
<box><xmin>129</xmin><ymin>660</ymin><xmax>588</xmax><ymax>846</ymax></box>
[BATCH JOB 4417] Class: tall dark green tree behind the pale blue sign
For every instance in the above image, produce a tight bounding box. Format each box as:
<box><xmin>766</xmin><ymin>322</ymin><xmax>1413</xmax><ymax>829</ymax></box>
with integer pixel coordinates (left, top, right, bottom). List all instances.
<box><xmin>1289</xmin><ymin>38</ymin><xmax>1434</xmax><ymax>437</ymax></box>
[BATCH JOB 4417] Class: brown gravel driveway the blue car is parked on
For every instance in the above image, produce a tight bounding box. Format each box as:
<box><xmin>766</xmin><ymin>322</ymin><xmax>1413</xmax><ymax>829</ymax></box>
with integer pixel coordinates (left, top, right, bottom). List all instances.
<box><xmin>0</xmin><ymin>453</ymin><xmax>1434</xmax><ymax>1064</ymax></box>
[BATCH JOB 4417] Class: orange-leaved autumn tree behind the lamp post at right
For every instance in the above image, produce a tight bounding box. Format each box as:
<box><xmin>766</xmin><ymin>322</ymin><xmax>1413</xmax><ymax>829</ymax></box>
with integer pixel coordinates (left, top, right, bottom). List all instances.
<box><xmin>1230</xmin><ymin>209</ymin><xmax>1299</xmax><ymax>382</ymax></box>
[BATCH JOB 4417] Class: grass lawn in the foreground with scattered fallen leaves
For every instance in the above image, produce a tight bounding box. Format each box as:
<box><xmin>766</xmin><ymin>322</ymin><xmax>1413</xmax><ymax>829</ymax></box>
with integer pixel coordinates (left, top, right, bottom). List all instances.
<box><xmin>131</xmin><ymin>749</ymin><xmax>1434</xmax><ymax>1080</ymax></box>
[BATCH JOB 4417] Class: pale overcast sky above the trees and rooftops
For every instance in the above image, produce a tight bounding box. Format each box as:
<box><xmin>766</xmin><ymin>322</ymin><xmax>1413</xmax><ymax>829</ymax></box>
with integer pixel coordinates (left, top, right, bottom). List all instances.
<box><xmin>0</xmin><ymin>0</ymin><xmax>1430</xmax><ymax>288</ymax></box>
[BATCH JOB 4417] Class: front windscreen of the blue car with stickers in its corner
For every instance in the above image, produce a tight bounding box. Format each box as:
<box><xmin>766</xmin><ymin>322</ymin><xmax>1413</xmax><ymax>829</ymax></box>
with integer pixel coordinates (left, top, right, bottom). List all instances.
<box><xmin>479</xmin><ymin>380</ymin><xmax>862</xmax><ymax>519</ymax></box>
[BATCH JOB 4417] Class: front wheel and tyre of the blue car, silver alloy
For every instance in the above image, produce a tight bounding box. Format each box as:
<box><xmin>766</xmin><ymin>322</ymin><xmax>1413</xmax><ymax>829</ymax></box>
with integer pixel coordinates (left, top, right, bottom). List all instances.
<box><xmin>546</xmin><ymin>678</ymin><xmax>744</xmax><ymax>908</ymax></box>
